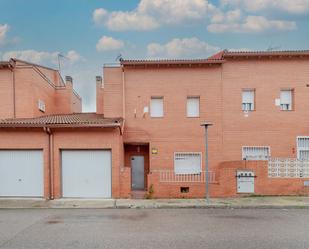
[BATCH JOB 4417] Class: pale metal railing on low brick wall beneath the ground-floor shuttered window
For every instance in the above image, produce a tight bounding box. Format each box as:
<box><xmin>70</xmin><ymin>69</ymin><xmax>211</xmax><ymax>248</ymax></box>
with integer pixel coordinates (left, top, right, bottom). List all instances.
<box><xmin>152</xmin><ymin>170</ymin><xmax>216</xmax><ymax>183</ymax></box>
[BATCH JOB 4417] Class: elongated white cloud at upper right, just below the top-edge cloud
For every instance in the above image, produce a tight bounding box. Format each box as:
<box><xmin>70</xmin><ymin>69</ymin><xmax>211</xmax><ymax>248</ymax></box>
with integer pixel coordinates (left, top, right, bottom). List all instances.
<box><xmin>207</xmin><ymin>15</ymin><xmax>297</xmax><ymax>33</ymax></box>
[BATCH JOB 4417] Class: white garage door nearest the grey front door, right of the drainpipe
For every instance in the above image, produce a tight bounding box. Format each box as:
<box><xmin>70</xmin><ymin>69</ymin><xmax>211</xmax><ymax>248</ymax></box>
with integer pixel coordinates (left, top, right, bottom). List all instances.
<box><xmin>62</xmin><ymin>150</ymin><xmax>112</xmax><ymax>198</ymax></box>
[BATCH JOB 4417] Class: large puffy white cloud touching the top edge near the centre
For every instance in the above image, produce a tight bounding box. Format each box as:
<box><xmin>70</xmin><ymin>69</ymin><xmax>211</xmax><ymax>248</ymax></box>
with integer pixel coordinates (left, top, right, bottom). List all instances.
<box><xmin>93</xmin><ymin>0</ymin><xmax>215</xmax><ymax>31</ymax></box>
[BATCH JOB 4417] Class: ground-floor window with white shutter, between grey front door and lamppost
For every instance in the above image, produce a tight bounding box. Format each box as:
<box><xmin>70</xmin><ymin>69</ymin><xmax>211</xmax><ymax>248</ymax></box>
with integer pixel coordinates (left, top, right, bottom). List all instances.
<box><xmin>174</xmin><ymin>152</ymin><xmax>202</xmax><ymax>174</ymax></box>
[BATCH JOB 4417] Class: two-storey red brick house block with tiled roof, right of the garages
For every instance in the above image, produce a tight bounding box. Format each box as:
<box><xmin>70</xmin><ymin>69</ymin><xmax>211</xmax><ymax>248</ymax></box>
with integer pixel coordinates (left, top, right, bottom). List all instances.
<box><xmin>97</xmin><ymin>51</ymin><xmax>309</xmax><ymax>198</ymax></box>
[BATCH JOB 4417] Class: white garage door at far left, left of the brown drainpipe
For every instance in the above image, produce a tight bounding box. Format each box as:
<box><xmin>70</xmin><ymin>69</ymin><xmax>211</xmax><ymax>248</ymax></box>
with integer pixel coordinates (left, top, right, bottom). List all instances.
<box><xmin>0</xmin><ymin>150</ymin><xmax>44</xmax><ymax>197</ymax></box>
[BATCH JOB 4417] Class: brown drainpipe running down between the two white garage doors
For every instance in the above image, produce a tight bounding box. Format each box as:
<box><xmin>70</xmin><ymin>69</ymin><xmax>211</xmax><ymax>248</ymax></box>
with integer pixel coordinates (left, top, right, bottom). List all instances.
<box><xmin>43</xmin><ymin>127</ymin><xmax>54</xmax><ymax>200</ymax></box>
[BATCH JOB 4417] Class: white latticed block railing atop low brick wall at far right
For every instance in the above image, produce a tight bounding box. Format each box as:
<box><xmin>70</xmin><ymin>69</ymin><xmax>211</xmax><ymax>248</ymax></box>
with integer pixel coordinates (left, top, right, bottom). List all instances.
<box><xmin>268</xmin><ymin>158</ymin><xmax>309</xmax><ymax>178</ymax></box>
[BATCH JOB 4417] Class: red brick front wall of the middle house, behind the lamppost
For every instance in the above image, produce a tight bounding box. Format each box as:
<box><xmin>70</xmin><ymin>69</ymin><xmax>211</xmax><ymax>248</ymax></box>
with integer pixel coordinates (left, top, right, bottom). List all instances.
<box><xmin>120</xmin><ymin>66</ymin><xmax>221</xmax><ymax>177</ymax></box>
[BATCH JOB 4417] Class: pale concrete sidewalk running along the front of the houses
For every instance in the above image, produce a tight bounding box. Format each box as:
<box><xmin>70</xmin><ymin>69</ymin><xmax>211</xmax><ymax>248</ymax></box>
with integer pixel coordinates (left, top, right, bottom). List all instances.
<box><xmin>0</xmin><ymin>196</ymin><xmax>309</xmax><ymax>209</ymax></box>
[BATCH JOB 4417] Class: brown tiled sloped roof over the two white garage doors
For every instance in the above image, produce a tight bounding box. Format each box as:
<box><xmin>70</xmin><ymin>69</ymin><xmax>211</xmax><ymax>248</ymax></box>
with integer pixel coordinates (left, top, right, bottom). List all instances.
<box><xmin>0</xmin><ymin>113</ymin><xmax>123</xmax><ymax>128</ymax></box>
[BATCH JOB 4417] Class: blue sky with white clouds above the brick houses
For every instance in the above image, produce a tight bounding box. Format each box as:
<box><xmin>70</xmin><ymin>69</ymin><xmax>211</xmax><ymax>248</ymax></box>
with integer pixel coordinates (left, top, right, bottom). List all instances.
<box><xmin>0</xmin><ymin>0</ymin><xmax>309</xmax><ymax>111</ymax></box>
